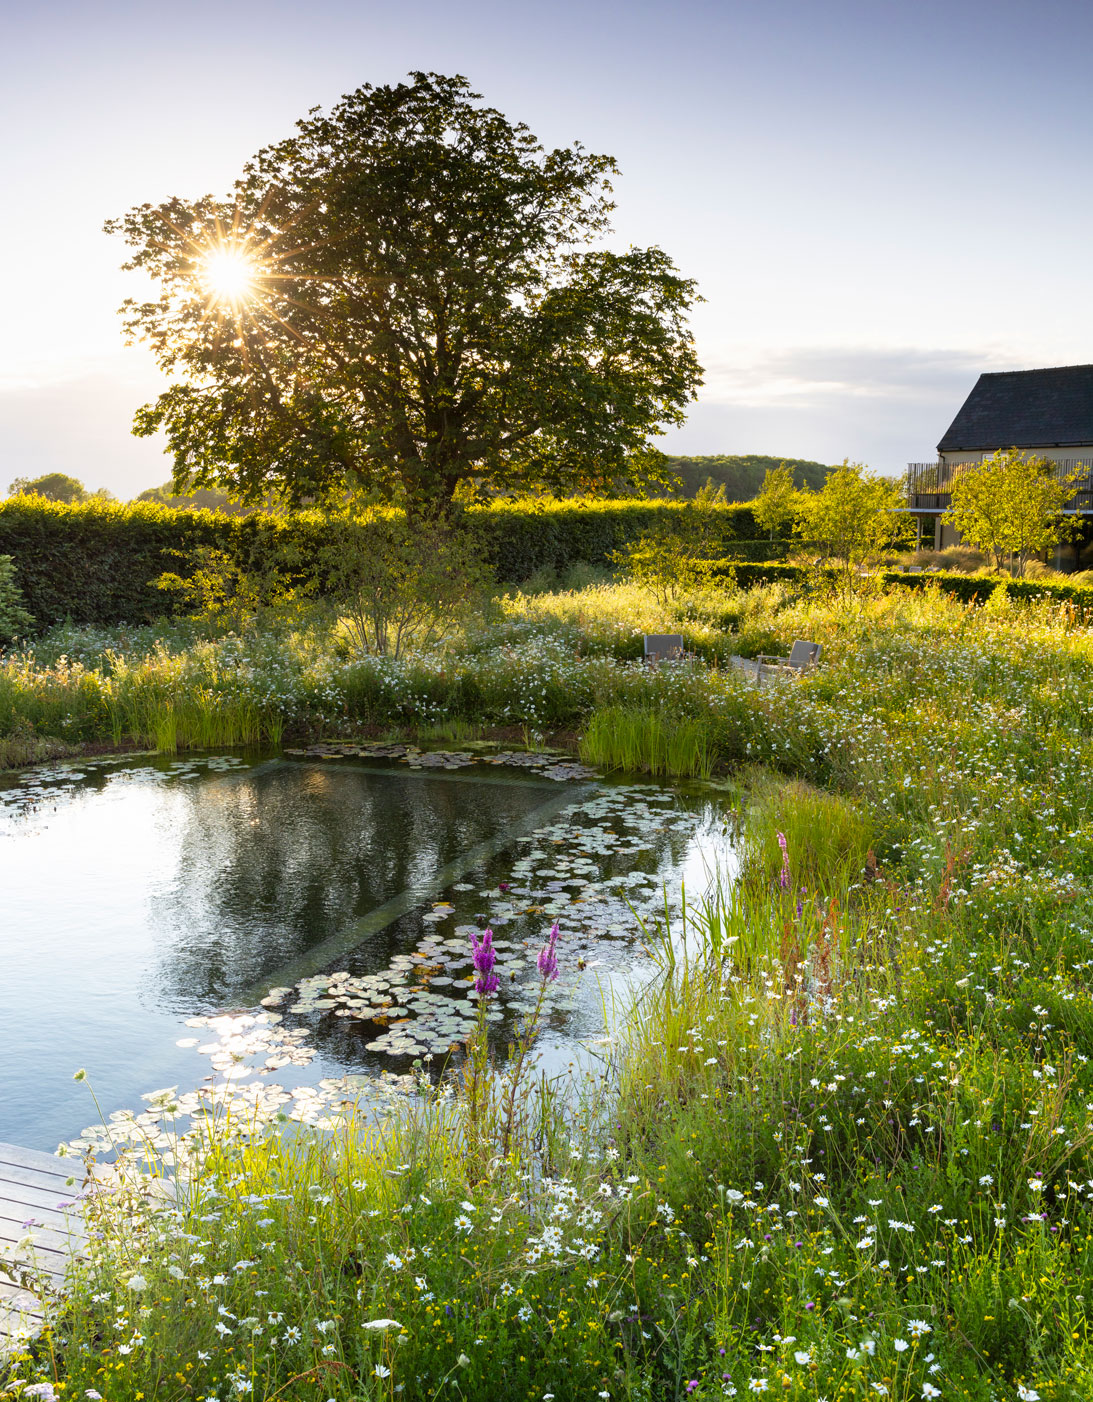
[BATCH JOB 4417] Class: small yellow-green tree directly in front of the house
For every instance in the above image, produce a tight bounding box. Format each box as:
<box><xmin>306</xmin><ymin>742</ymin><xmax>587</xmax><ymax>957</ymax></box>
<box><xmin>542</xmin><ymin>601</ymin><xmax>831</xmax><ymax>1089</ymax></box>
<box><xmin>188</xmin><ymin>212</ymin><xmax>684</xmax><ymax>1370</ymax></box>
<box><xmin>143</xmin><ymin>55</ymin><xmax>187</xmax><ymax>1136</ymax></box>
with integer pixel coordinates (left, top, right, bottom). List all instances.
<box><xmin>942</xmin><ymin>447</ymin><xmax>1082</xmax><ymax>575</ymax></box>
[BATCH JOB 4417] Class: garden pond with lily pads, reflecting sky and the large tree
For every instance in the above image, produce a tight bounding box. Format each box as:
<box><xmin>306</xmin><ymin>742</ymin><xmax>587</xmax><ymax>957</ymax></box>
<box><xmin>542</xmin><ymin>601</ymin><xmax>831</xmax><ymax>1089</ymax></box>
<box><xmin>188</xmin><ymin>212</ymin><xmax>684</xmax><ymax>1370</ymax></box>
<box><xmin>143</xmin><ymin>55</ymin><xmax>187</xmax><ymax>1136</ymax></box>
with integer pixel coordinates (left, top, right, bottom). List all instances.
<box><xmin>0</xmin><ymin>746</ymin><xmax>731</xmax><ymax>1150</ymax></box>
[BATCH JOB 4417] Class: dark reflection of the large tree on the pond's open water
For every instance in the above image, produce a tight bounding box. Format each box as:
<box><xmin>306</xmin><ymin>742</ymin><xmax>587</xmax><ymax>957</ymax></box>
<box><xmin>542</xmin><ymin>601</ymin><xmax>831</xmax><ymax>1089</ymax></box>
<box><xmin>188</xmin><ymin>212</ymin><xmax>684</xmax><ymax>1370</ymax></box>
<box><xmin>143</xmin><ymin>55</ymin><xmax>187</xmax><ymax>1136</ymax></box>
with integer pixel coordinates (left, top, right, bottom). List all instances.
<box><xmin>149</xmin><ymin>764</ymin><xmax>556</xmax><ymax>1012</ymax></box>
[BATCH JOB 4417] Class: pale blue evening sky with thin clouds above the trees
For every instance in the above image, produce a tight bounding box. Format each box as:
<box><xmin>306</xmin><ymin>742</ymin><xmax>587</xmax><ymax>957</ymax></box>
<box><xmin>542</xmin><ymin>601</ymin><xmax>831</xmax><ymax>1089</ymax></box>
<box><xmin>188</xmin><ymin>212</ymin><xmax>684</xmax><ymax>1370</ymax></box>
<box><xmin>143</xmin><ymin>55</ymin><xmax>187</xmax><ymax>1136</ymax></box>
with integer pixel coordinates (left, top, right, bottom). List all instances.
<box><xmin>0</xmin><ymin>0</ymin><xmax>1093</xmax><ymax>498</ymax></box>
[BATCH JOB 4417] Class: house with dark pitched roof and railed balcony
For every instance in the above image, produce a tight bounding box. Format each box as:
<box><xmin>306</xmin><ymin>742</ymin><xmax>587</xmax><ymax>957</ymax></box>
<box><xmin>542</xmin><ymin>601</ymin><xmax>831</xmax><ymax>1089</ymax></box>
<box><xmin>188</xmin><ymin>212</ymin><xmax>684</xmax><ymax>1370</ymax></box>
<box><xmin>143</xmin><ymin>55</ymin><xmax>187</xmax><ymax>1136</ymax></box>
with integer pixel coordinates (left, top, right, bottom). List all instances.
<box><xmin>907</xmin><ymin>365</ymin><xmax>1093</xmax><ymax>550</ymax></box>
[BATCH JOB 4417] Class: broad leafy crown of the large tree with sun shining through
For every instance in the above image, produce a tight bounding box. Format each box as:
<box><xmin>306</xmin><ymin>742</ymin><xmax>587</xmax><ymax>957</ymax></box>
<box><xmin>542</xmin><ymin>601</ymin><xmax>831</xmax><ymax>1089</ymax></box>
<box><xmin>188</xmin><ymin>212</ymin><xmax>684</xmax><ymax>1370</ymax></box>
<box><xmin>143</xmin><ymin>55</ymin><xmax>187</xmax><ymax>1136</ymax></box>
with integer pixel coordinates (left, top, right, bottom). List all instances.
<box><xmin>106</xmin><ymin>73</ymin><xmax>701</xmax><ymax>509</ymax></box>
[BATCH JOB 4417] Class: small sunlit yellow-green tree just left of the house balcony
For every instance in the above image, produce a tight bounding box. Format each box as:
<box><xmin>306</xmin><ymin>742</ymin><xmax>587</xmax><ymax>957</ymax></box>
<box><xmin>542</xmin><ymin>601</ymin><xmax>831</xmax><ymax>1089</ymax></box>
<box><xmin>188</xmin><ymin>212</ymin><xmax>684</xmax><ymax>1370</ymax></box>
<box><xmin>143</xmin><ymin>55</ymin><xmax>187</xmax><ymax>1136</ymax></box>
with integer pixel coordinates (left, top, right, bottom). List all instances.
<box><xmin>795</xmin><ymin>461</ymin><xmax>911</xmax><ymax>586</ymax></box>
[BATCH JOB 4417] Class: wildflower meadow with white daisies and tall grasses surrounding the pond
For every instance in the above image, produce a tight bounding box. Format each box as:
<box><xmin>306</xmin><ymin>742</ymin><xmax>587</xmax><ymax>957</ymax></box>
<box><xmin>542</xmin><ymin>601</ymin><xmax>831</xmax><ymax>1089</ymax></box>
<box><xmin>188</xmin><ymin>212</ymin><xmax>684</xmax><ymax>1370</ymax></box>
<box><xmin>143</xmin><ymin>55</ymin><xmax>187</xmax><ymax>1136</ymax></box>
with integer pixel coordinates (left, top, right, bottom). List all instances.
<box><xmin>8</xmin><ymin>589</ymin><xmax>1093</xmax><ymax>1402</ymax></box>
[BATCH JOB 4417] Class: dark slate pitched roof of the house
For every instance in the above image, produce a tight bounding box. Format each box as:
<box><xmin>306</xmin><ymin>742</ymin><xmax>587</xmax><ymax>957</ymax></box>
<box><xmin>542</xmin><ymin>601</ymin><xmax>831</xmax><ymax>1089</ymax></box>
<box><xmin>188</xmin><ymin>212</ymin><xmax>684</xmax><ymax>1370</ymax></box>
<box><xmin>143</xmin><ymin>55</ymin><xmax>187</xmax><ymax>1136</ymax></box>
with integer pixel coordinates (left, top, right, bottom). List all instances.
<box><xmin>937</xmin><ymin>365</ymin><xmax>1093</xmax><ymax>453</ymax></box>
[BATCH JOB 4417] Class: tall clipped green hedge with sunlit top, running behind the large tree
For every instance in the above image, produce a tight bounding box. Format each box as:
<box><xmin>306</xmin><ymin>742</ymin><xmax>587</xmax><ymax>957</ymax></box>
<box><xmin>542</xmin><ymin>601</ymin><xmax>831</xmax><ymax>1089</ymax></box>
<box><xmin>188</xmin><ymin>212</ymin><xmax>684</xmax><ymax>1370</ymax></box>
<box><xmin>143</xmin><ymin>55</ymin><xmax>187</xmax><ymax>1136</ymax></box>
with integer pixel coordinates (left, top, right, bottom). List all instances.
<box><xmin>0</xmin><ymin>496</ymin><xmax>771</xmax><ymax>625</ymax></box>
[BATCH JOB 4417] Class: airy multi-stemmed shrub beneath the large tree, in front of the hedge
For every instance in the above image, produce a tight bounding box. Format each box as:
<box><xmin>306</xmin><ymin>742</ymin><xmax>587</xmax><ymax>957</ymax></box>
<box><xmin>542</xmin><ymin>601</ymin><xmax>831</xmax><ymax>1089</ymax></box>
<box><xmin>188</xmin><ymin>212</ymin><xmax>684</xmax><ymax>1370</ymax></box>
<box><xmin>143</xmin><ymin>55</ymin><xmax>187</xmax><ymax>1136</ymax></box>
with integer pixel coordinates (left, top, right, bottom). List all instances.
<box><xmin>317</xmin><ymin>508</ymin><xmax>489</xmax><ymax>658</ymax></box>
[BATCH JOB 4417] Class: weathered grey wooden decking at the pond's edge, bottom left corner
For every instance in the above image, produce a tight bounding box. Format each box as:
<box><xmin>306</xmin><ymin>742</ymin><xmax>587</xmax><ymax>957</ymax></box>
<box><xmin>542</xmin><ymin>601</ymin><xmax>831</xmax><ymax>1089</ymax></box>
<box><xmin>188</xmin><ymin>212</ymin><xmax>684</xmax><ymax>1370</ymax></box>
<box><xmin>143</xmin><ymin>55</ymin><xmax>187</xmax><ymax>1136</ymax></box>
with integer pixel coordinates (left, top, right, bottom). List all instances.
<box><xmin>0</xmin><ymin>1143</ymin><xmax>84</xmax><ymax>1354</ymax></box>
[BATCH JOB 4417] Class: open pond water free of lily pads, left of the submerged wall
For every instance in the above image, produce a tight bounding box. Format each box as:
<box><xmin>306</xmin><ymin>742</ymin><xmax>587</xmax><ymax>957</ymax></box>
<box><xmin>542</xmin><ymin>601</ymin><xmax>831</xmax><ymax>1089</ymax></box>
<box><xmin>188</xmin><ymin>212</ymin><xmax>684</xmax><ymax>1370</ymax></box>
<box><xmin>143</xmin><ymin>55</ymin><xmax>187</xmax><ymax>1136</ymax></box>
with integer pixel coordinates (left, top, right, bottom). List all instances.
<box><xmin>0</xmin><ymin>760</ymin><xmax>561</xmax><ymax>1150</ymax></box>
